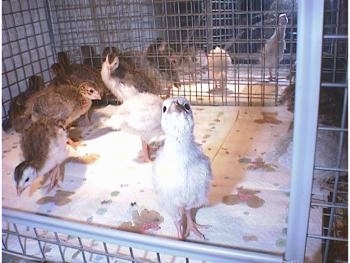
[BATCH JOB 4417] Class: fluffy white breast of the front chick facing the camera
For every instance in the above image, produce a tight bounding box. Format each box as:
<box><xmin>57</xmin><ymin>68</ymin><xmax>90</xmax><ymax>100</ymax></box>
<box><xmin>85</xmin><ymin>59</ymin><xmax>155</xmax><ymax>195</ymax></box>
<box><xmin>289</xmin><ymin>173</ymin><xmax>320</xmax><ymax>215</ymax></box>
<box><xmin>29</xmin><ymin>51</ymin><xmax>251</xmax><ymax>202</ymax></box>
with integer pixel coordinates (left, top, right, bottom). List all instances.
<box><xmin>153</xmin><ymin>141</ymin><xmax>212</xmax><ymax>218</ymax></box>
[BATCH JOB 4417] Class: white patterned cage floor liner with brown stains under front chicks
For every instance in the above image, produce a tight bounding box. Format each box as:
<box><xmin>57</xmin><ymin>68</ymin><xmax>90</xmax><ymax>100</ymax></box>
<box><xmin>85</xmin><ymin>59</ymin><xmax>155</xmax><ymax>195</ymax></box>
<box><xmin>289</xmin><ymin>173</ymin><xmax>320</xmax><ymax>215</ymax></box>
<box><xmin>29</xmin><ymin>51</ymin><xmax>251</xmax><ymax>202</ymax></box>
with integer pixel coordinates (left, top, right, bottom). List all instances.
<box><xmin>2</xmin><ymin>105</ymin><xmax>318</xmax><ymax>262</ymax></box>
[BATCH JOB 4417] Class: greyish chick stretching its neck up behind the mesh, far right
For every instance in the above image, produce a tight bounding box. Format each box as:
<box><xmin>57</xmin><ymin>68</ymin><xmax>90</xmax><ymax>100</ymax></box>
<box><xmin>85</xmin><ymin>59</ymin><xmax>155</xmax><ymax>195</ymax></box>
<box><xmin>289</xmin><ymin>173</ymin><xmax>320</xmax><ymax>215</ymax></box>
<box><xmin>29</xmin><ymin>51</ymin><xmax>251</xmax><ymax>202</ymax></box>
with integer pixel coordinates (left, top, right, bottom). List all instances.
<box><xmin>260</xmin><ymin>14</ymin><xmax>288</xmax><ymax>80</ymax></box>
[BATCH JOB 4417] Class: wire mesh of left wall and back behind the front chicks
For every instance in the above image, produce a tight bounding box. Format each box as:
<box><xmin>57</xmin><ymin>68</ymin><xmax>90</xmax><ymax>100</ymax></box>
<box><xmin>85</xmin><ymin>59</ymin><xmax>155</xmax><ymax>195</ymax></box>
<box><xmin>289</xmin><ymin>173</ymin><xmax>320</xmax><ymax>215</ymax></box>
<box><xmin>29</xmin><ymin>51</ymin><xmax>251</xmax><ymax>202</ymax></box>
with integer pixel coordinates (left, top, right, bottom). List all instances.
<box><xmin>2</xmin><ymin>0</ymin><xmax>296</xmax><ymax>126</ymax></box>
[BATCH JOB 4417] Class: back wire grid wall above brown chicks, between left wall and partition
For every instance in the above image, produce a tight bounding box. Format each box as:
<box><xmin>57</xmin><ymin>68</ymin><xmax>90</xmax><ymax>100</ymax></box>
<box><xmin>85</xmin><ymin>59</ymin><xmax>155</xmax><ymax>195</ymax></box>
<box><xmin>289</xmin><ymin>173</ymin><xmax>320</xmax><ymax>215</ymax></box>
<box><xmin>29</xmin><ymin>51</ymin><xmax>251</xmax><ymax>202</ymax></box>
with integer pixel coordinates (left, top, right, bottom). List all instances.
<box><xmin>49</xmin><ymin>0</ymin><xmax>156</xmax><ymax>54</ymax></box>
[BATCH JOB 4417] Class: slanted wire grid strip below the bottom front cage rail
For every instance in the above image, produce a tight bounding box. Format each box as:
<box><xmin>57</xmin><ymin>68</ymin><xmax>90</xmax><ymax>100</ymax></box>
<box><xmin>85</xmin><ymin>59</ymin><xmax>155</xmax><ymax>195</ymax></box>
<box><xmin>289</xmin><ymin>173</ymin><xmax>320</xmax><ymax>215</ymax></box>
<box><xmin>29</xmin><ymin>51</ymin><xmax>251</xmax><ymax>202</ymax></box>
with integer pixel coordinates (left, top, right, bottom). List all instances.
<box><xmin>2</xmin><ymin>221</ymin><xmax>161</xmax><ymax>262</ymax></box>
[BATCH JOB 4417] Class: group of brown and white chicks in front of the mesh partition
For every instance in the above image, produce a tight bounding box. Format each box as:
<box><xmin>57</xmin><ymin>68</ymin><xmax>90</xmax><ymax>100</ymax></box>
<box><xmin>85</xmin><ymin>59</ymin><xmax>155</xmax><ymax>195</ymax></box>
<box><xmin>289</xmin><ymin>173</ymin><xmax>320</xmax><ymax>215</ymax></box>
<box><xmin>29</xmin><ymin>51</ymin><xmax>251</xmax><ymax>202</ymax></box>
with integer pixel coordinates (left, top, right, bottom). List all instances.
<box><xmin>10</xmin><ymin>40</ymin><xmax>212</xmax><ymax>239</ymax></box>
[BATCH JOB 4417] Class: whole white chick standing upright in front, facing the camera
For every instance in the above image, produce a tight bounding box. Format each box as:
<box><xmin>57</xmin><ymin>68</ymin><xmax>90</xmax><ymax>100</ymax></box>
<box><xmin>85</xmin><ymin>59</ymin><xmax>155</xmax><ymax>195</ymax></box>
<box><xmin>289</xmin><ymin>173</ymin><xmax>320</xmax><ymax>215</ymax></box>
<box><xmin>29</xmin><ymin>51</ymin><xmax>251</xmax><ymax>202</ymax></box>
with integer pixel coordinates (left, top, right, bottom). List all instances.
<box><xmin>152</xmin><ymin>97</ymin><xmax>212</xmax><ymax>239</ymax></box>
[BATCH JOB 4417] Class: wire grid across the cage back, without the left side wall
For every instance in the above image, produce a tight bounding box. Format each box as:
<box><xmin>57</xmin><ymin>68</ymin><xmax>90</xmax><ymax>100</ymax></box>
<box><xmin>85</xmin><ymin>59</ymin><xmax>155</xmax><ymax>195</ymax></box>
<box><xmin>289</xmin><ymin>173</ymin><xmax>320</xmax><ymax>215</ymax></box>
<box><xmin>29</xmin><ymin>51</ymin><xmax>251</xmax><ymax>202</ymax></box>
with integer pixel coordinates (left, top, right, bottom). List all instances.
<box><xmin>5</xmin><ymin>0</ymin><xmax>296</xmax><ymax>116</ymax></box>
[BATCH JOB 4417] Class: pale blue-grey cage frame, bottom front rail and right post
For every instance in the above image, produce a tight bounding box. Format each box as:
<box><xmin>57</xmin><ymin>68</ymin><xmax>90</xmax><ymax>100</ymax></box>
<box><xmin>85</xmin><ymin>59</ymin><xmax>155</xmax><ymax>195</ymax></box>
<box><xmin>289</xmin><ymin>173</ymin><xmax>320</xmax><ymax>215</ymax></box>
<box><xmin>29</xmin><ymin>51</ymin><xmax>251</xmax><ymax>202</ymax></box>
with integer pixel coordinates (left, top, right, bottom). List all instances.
<box><xmin>2</xmin><ymin>0</ymin><xmax>347</xmax><ymax>262</ymax></box>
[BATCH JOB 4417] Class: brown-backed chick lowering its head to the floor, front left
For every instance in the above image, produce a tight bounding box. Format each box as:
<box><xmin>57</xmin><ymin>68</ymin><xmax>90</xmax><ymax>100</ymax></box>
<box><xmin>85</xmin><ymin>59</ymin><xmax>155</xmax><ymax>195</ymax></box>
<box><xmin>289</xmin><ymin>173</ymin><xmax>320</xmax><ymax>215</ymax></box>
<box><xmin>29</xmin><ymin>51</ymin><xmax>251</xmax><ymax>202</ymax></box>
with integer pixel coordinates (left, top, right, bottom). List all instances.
<box><xmin>14</xmin><ymin>118</ymin><xmax>69</xmax><ymax>195</ymax></box>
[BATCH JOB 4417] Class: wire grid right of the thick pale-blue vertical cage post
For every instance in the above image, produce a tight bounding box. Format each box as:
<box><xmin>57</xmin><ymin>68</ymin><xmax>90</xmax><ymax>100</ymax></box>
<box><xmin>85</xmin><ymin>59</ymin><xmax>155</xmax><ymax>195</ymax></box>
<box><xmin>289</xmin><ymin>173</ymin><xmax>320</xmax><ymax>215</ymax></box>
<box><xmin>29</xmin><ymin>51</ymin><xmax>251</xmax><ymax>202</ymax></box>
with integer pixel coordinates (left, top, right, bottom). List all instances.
<box><xmin>307</xmin><ymin>1</ymin><xmax>348</xmax><ymax>262</ymax></box>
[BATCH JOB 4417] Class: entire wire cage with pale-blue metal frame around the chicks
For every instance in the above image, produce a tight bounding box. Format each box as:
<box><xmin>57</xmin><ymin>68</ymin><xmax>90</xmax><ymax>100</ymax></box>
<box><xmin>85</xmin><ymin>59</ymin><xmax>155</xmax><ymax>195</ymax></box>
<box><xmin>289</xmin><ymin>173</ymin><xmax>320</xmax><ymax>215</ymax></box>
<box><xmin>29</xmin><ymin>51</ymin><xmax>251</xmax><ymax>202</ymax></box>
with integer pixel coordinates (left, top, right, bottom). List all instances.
<box><xmin>2</xmin><ymin>0</ymin><xmax>348</xmax><ymax>262</ymax></box>
